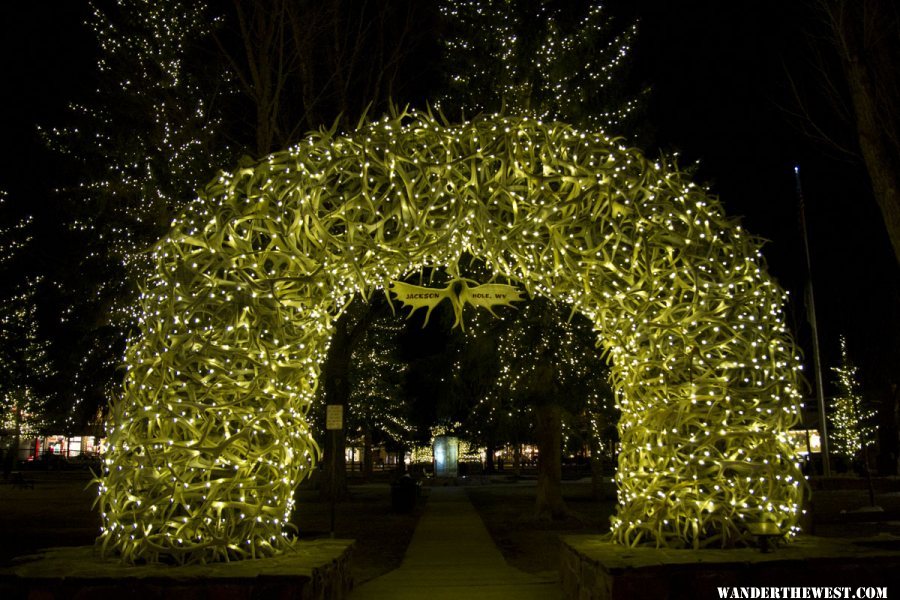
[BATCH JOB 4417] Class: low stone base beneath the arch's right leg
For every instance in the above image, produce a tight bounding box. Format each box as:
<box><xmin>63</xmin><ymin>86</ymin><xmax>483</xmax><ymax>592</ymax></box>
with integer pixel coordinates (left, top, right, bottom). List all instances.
<box><xmin>560</xmin><ymin>535</ymin><xmax>900</xmax><ymax>600</ymax></box>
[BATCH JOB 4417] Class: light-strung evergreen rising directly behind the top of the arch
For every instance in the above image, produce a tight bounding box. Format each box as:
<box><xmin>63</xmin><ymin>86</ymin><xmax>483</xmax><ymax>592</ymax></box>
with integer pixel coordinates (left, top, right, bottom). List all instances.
<box><xmin>436</xmin><ymin>0</ymin><xmax>640</xmax><ymax>132</ymax></box>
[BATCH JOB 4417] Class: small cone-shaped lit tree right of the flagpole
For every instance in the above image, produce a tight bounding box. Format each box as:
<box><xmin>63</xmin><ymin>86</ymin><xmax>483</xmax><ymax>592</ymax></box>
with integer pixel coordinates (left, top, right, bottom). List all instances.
<box><xmin>829</xmin><ymin>336</ymin><xmax>878</xmax><ymax>463</ymax></box>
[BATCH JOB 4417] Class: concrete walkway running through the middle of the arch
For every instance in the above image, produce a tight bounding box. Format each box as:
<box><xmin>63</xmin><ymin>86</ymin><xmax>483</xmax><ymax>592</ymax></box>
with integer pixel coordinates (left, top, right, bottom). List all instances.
<box><xmin>350</xmin><ymin>487</ymin><xmax>562</xmax><ymax>600</ymax></box>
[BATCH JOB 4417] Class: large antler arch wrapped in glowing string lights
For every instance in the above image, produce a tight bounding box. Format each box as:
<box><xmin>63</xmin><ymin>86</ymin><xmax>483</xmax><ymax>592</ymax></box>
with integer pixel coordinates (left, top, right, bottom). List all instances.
<box><xmin>99</xmin><ymin>112</ymin><xmax>803</xmax><ymax>563</ymax></box>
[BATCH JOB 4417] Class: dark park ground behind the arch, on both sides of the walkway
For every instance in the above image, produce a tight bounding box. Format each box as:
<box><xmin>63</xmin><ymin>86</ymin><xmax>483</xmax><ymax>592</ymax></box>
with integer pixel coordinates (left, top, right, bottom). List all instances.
<box><xmin>0</xmin><ymin>470</ymin><xmax>900</xmax><ymax>585</ymax></box>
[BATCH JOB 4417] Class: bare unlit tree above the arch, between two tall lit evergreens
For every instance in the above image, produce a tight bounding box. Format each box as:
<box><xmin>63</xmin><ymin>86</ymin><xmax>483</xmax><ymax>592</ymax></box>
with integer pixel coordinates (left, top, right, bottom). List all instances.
<box><xmin>216</xmin><ymin>0</ymin><xmax>428</xmax><ymax>155</ymax></box>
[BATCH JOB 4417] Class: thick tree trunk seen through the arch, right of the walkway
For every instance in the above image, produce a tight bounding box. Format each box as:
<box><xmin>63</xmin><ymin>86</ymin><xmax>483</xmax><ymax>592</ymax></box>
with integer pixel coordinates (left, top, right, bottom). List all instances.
<box><xmin>534</xmin><ymin>402</ymin><xmax>569</xmax><ymax>519</ymax></box>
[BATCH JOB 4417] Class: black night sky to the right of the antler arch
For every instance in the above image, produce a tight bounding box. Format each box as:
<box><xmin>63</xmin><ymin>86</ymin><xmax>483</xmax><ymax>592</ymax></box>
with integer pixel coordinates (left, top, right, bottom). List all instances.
<box><xmin>624</xmin><ymin>1</ymin><xmax>900</xmax><ymax>408</ymax></box>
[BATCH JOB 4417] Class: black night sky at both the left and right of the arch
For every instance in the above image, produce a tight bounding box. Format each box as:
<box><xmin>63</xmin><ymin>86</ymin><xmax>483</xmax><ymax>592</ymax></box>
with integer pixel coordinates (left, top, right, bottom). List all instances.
<box><xmin>0</xmin><ymin>0</ymin><xmax>900</xmax><ymax>422</ymax></box>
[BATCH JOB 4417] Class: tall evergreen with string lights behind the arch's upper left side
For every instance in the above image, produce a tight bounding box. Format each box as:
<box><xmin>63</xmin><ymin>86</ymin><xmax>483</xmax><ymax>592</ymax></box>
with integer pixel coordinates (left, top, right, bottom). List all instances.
<box><xmin>45</xmin><ymin>0</ymin><xmax>234</xmax><ymax>278</ymax></box>
